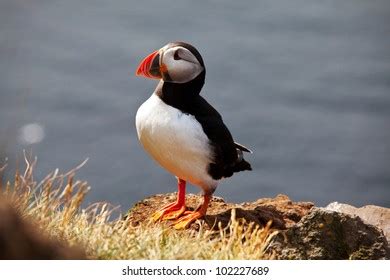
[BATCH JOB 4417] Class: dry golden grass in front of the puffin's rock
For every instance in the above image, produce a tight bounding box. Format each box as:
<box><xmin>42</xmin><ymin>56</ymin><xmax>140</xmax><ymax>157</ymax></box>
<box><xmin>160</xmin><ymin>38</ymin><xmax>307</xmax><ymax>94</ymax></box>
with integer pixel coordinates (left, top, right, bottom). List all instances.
<box><xmin>0</xmin><ymin>154</ymin><xmax>275</xmax><ymax>259</ymax></box>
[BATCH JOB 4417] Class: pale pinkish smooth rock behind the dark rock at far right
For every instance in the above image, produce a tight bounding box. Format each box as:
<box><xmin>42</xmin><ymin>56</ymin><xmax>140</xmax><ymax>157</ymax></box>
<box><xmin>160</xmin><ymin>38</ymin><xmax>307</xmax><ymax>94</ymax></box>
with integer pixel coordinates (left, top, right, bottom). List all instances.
<box><xmin>326</xmin><ymin>202</ymin><xmax>390</xmax><ymax>243</ymax></box>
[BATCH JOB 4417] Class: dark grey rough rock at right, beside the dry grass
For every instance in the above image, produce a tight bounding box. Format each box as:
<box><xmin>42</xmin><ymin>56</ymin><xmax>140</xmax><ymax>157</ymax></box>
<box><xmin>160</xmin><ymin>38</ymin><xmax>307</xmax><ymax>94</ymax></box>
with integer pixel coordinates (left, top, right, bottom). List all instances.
<box><xmin>269</xmin><ymin>208</ymin><xmax>390</xmax><ymax>260</ymax></box>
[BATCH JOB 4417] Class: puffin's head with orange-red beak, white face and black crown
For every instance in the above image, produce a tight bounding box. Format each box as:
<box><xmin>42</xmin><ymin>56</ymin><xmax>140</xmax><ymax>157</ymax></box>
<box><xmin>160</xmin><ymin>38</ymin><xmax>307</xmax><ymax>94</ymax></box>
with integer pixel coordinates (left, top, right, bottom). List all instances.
<box><xmin>136</xmin><ymin>42</ymin><xmax>205</xmax><ymax>84</ymax></box>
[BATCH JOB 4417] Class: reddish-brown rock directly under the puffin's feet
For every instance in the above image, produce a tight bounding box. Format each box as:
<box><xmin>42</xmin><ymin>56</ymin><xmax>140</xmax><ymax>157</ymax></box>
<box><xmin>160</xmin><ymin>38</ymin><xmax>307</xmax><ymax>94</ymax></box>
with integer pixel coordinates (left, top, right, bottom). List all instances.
<box><xmin>127</xmin><ymin>193</ymin><xmax>314</xmax><ymax>230</ymax></box>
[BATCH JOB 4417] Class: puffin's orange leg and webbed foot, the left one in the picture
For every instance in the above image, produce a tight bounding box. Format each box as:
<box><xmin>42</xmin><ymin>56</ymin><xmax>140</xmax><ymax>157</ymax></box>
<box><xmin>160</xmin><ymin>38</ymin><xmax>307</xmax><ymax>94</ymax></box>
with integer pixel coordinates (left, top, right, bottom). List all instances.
<box><xmin>152</xmin><ymin>178</ymin><xmax>186</xmax><ymax>221</ymax></box>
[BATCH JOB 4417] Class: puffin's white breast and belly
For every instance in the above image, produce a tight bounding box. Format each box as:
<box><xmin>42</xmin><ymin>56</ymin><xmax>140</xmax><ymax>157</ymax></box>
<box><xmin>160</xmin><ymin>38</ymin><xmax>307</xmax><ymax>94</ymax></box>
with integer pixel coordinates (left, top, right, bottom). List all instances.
<box><xmin>136</xmin><ymin>94</ymin><xmax>217</xmax><ymax>192</ymax></box>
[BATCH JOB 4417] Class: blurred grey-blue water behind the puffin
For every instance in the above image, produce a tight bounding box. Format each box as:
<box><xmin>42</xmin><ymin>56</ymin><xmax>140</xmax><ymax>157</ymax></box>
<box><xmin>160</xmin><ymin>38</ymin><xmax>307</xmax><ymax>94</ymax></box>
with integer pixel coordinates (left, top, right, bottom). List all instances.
<box><xmin>0</xmin><ymin>0</ymin><xmax>390</xmax><ymax>208</ymax></box>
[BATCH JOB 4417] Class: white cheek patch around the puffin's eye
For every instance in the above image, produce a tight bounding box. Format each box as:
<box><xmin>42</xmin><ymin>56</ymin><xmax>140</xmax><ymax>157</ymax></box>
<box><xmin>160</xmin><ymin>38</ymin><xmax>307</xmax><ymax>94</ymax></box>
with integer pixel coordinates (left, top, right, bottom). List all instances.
<box><xmin>162</xmin><ymin>47</ymin><xmax>203</xmax><ymax>83</ymax></box>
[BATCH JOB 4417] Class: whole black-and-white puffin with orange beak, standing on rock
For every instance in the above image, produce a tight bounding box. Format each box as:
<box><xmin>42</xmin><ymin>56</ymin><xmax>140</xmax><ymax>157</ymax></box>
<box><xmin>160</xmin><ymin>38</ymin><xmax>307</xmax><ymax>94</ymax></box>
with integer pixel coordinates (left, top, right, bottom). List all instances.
<box><xmin>135</xmin><ymin>42</ymin><xmax>252</xmax><ymax>229</ymax></box>
